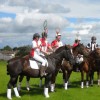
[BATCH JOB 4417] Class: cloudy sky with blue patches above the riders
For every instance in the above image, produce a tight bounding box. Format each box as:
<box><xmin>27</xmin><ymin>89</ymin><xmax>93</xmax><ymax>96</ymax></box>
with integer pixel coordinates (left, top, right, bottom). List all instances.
<box><xmin>0</xmin><ymin>0</ymin><xmax>100</xmax><ymax>48</ymax></box>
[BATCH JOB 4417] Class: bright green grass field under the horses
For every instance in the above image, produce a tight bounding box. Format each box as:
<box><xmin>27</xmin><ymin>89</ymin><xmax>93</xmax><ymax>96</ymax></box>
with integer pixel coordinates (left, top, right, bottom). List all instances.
<box><xmin>0</xmin><ymin>61</ymin><xmax>100</xmax><ymax>100</ymax></box>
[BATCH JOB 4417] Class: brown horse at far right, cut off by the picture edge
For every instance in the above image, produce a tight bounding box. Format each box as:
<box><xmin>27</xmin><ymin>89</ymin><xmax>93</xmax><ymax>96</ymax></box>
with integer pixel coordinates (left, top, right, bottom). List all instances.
<box><xmin>85</xmin><ymin>48</ymin><xmax>100</xmax><ymax>86</ymax></box>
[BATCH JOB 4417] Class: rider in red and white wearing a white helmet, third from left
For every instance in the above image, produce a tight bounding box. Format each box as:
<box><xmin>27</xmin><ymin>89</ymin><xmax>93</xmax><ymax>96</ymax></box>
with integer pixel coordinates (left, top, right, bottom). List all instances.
<box><xmin>51</xmin><ymin>32</ymin><xmax>63</xmax><ymax>50</ymax></box>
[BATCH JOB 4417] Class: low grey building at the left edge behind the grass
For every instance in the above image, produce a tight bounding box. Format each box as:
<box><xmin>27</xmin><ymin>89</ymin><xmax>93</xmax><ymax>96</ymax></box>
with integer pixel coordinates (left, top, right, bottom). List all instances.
<box><xmin>0</xmin><ymin>51</ymin><xmax>15</xmax><ymax>60</ymax></box>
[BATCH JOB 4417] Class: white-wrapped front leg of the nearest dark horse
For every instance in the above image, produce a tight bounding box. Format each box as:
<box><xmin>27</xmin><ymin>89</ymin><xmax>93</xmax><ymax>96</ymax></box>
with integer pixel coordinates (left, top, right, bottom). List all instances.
<box><xmin>44</xmin><ymin>74</ymin><xmax>52</xmax><ymax>98</ymax></box>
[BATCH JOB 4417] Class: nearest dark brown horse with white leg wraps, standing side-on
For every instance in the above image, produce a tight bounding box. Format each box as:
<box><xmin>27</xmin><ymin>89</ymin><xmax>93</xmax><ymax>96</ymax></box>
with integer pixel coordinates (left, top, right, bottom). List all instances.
<box><xmin>7</xmin><ymin>46</ymin><xmax>74</xmax><ymax>99</ymax></box>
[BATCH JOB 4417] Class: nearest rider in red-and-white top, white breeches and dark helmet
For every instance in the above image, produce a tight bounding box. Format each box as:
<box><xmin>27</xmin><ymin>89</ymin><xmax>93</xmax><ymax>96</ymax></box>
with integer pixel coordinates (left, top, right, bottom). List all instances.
<box><xmin>30</xmin><ymin>33</ymin><xmax>46</xmax><ymax>77</ymax></box>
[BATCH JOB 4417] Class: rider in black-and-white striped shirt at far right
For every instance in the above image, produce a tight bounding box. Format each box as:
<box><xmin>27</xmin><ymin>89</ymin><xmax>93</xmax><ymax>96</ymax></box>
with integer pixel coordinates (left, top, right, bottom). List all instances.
<box><xmin>87</xmin><ymin>36</ymin><xmax>98</xmax><ymax>51</ymax></box>
